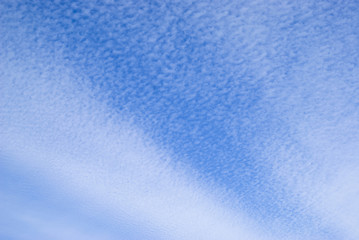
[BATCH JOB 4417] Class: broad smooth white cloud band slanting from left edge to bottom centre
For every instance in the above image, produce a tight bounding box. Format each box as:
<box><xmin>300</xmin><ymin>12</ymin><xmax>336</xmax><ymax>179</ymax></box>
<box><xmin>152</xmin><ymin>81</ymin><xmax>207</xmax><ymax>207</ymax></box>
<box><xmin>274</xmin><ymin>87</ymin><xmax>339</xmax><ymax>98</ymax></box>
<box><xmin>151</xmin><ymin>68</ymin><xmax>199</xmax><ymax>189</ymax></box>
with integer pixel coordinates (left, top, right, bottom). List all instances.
<box><xmin>0</xmin><ymin>27</ymin><xmax>270</xmax><ymax>240</ymax></box>
